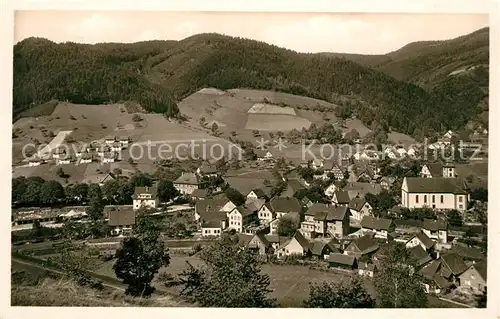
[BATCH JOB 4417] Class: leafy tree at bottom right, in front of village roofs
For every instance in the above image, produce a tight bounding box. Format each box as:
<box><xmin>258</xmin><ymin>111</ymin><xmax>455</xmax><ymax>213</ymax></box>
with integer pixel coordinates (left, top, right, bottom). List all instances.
<box><xmin>374</xmin><ymin>243</ymin><xmax>427</xmax><ymax>308</ymax></box>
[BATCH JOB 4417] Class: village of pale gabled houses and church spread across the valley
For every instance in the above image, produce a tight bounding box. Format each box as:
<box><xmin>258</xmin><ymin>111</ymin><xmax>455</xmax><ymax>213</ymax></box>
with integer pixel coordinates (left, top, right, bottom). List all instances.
<box><xmin>12</xmin><ymin>126</ymin><xmax>487</xmax><ymax>304</ymax></box>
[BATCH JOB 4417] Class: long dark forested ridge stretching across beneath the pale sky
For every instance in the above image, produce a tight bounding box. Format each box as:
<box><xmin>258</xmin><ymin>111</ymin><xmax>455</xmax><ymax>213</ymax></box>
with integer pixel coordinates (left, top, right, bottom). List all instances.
<box><xmin>14</xmin><ymin>34</ymin><xmax>488</xmax><ymax>138</ymax></box>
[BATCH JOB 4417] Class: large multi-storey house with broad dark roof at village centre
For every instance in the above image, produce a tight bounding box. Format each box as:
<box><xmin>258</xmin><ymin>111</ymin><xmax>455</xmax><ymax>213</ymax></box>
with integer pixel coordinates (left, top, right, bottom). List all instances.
<box><xmin>300</xmin><ymin>203</ymin><xmax>349</xmax><ymax>238</ymax></box>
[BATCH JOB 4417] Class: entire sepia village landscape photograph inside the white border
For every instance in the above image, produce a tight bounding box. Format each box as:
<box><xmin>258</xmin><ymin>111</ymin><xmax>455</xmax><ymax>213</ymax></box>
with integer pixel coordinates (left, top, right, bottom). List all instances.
<box><xmin>6</xmin><ymin>1</ymin><xmax>498</xmax><ymax>309</ymax></box>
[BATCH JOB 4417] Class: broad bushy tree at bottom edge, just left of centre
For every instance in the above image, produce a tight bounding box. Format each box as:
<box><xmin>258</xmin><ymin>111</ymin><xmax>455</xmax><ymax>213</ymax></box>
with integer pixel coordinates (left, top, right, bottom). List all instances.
<box><xmin>180</xmin><ymin>234</ymin><xmax>275</xmax><ymax>308</ymax></box>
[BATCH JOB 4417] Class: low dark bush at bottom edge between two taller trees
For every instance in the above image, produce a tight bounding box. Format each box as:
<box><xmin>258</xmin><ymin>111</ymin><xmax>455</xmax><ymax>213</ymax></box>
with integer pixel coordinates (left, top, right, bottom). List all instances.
<box><xmin>304</xmin><ymin>277</ymin><xmax>375</xmax><ymax>308</ymax></box>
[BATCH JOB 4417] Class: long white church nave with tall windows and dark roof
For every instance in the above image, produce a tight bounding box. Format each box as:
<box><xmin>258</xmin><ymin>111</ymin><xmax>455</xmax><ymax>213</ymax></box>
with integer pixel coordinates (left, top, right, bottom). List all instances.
<box><xmin>401</xmin><ymin>177</ymin><xmax>469</xmax><ymax>211</ymax></box>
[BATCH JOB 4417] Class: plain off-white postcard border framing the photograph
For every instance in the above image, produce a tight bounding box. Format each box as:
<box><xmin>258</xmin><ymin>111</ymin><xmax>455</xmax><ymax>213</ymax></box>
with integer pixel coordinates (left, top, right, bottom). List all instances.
<box><xmin>0</xmin><ymin>0</ymin><xmax>500</xmax><ymax>319</ymax></box>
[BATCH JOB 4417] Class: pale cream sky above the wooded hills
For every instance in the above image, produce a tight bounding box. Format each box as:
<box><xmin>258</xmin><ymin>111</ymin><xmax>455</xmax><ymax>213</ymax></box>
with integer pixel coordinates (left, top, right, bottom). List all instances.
<box><xmin>14</xmin><ymin>10</ymin><xmax>488</xmax><ymax>54</ymax></box>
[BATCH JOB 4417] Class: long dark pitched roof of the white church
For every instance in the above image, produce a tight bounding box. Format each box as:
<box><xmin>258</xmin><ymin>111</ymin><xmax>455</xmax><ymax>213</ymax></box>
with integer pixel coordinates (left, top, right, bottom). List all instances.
<box><xmin>405</xmin><ymin>177</ymin><xmax>467</xmax><ymax>195</ymax></box>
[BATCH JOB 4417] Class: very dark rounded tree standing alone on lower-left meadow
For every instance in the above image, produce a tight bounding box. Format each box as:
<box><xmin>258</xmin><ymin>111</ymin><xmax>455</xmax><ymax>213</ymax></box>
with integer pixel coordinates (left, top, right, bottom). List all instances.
<box><xmin>113</xmin><ymin>212</ymin><xmax>170</xmax><ymax>297</ymax></box>
